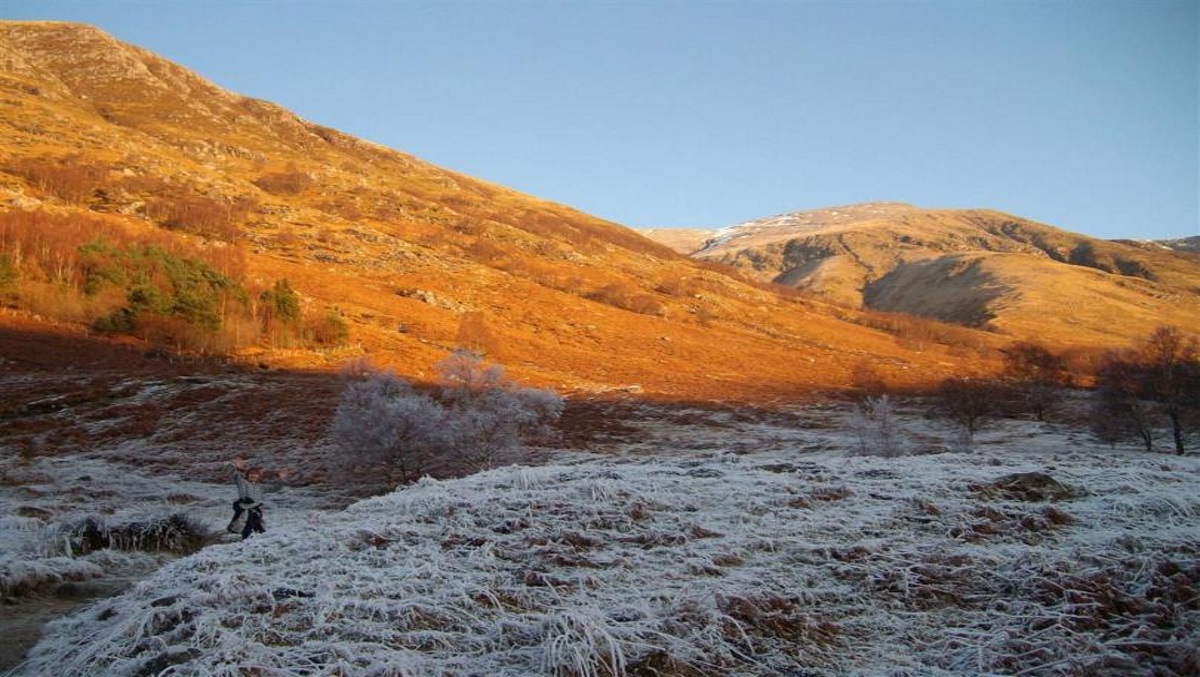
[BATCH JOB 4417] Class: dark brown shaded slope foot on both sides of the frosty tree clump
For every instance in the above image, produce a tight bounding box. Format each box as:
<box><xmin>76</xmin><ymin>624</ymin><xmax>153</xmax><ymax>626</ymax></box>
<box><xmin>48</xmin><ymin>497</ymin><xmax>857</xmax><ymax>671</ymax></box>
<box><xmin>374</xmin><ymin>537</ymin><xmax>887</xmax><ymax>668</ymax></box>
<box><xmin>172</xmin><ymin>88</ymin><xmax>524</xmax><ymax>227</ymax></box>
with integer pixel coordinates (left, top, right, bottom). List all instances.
<box><xmin>0</xmin><ymin>317</ymin><xmax>878</xmax><ymax>492</ymax></box>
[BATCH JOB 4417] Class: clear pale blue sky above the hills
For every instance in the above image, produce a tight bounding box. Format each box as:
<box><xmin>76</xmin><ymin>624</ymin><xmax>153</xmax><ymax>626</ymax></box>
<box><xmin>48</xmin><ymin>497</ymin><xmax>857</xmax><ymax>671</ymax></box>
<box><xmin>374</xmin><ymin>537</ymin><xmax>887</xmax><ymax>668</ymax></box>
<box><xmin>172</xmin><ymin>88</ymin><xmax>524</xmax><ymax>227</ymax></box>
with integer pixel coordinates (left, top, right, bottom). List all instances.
<box><xmin>0</xmin><ymin>0</ymin><xmax>1200</xmax><ymax>238</ymax></box>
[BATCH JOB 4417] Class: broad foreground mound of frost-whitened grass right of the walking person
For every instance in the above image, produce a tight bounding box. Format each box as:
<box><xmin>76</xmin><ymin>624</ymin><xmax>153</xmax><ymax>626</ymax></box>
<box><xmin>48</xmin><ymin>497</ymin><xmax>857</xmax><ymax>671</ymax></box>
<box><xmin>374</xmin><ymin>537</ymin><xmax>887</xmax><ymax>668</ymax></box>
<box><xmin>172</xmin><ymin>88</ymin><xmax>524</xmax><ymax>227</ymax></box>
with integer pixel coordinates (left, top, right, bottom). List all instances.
<box><xmin>11</xmin><ymin>431</ymin><xmax>1200</xmax><ymax>676</ymax></box>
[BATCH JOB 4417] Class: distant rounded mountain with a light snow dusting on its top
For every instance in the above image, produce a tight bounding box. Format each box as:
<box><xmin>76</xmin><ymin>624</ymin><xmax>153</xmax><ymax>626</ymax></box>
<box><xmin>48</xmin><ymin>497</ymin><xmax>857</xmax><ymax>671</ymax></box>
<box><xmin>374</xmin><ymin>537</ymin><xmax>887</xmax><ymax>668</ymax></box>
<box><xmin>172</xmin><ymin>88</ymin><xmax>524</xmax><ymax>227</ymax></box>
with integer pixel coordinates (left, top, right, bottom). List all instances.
<box><xmin>647</xmin><ymin>203</ymin><xmax>1200</xmax><ymax>347</ymax></box>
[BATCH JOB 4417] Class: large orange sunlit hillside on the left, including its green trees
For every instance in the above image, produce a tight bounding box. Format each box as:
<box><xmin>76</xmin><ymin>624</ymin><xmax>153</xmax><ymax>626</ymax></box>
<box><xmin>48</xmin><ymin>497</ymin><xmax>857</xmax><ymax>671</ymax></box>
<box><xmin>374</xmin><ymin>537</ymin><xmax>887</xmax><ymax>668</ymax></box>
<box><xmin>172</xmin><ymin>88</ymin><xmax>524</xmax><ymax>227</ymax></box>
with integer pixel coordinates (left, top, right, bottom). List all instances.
<box><xmin>0</xmin><ymin>22</ymin><xmax>995</xmax><ymax>397</ymax></box>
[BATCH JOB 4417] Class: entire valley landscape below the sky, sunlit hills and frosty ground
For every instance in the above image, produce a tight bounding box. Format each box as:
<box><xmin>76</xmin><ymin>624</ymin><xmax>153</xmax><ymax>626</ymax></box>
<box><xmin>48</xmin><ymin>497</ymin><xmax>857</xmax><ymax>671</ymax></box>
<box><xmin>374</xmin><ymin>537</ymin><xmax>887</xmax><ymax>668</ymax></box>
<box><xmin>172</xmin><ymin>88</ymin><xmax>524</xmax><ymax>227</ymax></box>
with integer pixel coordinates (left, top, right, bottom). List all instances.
<box><xmin>0</xmin><ymin>22</ymin><xmax>1200</xmax><ymax>677</ymax></box>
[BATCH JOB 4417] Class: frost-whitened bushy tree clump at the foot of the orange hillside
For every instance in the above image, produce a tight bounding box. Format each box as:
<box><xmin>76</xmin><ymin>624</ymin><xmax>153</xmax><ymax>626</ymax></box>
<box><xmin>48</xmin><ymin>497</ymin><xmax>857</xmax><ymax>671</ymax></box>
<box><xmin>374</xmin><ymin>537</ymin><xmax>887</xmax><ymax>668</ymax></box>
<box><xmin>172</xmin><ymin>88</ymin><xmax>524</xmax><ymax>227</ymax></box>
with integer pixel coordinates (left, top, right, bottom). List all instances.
<box><xmin>330</xmin><ymin>352</ymin><xmax>563</xmax><ymax>484</ymax></box>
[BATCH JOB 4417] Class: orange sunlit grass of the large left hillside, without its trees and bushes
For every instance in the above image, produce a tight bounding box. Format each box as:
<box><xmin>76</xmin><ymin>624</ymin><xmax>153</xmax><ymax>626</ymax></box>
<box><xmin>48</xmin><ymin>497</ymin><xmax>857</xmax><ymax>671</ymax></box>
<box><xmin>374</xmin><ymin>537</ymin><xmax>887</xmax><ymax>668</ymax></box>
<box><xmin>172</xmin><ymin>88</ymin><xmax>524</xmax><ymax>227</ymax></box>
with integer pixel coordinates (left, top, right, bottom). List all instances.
<box><xmin>0</xmin><ymin>23</ymin><xmax>1003</xmax><ymax>397</ymax></box>
